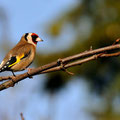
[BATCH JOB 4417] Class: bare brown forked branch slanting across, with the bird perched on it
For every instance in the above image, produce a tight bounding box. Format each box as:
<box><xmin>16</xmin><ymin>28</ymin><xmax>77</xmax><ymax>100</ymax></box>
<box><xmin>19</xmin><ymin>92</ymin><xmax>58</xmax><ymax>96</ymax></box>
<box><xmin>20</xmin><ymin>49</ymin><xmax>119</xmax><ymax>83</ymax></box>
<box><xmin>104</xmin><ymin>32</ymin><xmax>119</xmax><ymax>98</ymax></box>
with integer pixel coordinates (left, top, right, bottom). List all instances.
<box><xmin>0</xmin><ymin>44</ymin><xmax>120</xmax><ymax>90</ymax></box>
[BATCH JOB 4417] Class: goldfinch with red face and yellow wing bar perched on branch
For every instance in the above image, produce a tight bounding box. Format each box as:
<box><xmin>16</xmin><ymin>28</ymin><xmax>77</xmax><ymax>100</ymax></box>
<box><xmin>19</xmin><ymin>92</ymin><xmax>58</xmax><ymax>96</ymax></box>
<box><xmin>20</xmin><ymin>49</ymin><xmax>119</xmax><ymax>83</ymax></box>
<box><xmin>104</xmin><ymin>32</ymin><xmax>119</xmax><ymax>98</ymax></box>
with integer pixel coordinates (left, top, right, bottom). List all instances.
<box><xmin>0</xmin><ymin>33</ymin><xmax>43</xmax><ymax>76</ymax></box>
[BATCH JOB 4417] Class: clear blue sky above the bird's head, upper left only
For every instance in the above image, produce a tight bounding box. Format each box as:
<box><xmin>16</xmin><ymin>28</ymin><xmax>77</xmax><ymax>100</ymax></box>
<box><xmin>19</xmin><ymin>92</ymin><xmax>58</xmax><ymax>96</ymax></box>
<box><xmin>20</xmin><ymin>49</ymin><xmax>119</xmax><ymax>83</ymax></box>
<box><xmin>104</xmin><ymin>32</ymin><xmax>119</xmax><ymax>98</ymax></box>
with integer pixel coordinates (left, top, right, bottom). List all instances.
<box><xmin>0</xmin><ymin>0</ymin><xmax>77</xmax><ymax>51</ymax></box>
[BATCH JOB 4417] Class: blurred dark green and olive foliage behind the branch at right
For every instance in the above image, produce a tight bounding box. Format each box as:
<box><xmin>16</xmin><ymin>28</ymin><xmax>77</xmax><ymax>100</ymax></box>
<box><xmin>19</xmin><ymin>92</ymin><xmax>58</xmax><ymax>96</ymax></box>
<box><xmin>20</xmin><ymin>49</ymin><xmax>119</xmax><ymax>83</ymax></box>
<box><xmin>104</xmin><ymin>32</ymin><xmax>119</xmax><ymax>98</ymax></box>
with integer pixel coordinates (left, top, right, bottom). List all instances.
<box><xmin>36</xmin><ymin>0</ymin><xmax>120</xmax><ymax>120</ymax></box>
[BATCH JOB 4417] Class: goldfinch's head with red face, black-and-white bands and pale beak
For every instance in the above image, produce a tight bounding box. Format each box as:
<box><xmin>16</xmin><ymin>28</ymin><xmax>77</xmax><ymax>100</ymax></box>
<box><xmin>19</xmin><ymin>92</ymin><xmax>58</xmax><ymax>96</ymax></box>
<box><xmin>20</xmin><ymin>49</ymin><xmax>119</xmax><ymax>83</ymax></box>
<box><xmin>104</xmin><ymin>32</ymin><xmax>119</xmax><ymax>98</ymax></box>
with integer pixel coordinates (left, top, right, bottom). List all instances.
<box><xmin>22</xmin><ymin>33</ymin><xmax>43</xmax><ymax>46</ymax></box>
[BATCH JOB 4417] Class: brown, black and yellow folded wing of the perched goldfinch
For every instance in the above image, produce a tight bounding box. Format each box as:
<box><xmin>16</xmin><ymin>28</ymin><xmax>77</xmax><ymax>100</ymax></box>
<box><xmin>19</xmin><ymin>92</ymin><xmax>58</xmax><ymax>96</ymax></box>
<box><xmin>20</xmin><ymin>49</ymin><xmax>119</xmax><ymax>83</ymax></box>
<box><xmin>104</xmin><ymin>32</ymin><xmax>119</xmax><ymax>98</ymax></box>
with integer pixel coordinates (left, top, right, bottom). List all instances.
<box><xmin>0</xmin><ymin>44</ymin><xmax>31</xmax><ymax>72</ymax></box>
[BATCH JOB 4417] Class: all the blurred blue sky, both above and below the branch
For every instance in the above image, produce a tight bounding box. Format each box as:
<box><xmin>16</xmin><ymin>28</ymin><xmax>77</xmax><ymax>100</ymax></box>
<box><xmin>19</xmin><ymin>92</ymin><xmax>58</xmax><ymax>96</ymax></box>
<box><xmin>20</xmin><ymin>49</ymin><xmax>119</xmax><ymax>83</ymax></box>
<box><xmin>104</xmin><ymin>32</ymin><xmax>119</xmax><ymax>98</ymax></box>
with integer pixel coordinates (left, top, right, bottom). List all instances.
<box><xmin>0</xmin><ymin>0</ymin><xmax>101</xmax><ymax>120</ymax></box>
